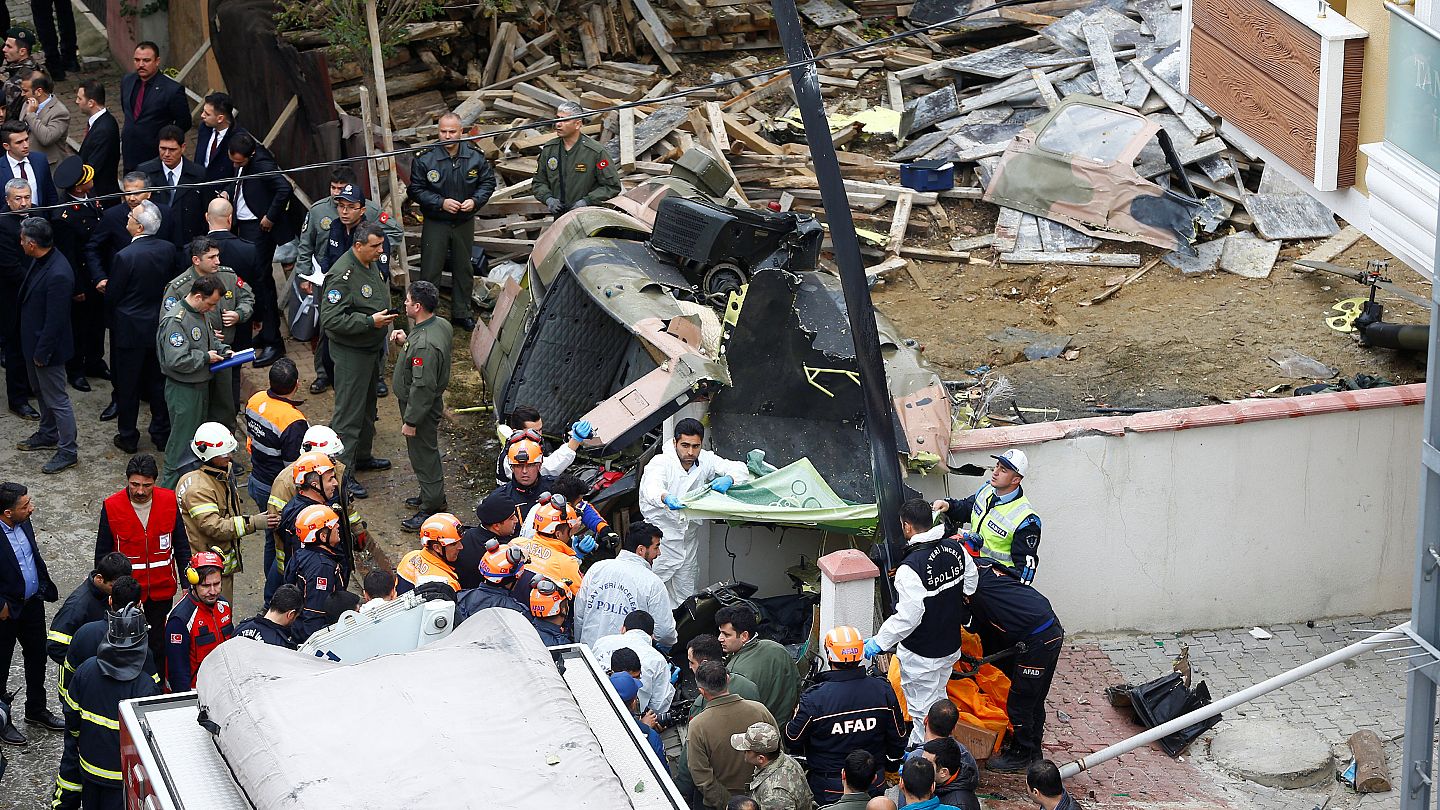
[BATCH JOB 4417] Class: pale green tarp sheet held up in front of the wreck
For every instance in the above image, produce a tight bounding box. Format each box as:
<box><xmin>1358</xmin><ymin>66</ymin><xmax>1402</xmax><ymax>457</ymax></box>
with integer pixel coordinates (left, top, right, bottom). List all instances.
<box><xmin>684</xmin><ymin>458</ymin><xmax>877</xmax><ymax>535</ymax></box>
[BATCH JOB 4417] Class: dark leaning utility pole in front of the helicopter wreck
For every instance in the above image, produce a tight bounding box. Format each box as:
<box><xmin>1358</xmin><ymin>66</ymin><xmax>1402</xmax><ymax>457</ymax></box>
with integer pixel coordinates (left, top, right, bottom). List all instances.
<box><xmin>772</xmin><ymin>0</ymin><xmax>904</xmax><ymax>604</ymax></box>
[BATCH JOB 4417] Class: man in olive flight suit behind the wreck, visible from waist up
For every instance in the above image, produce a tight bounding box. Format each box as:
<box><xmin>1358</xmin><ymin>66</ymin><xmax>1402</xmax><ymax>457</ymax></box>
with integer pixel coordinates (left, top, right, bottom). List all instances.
<box><xmin>530</xmin><ymin>102</ymin><xmax>621</xmax><ymax>216</ymax></box>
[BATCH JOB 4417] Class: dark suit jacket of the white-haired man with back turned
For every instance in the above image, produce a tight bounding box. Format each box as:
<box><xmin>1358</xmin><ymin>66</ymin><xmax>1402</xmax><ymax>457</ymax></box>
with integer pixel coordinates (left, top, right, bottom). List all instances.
<box><xmin>105</xmin><ymin>236</ymin><xmax>176</xmax><ymax>349</ymax></box>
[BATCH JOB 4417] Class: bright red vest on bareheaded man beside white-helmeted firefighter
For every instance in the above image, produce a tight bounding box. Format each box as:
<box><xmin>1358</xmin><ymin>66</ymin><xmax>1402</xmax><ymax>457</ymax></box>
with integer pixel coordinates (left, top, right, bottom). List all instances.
<box><xmin>95</xmin><ymin>487</ymin><xmax>190</xmax><ymax>602</ymax></box>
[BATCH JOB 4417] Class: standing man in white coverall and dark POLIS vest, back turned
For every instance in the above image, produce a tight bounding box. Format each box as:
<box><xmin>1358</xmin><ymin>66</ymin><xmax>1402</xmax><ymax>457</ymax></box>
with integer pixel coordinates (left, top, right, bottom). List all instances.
<box><xmin>865</xmin><ymin>497</ymin><xmax>979</xmax><ymax>745</ymax></box>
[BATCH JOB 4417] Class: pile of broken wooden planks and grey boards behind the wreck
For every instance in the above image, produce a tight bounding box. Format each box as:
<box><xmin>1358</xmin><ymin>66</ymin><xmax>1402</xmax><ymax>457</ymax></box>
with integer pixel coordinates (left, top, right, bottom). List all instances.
<box><xmin>285</xmin><ymin>0</ymin><xmax>1338</xmax><ymax>284</ymax></box>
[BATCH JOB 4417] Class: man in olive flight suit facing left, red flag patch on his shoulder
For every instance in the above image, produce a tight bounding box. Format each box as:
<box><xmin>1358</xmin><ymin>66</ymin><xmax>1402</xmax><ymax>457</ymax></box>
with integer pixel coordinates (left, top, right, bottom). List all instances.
<box><xmin>392</xmin><ymin>281</ymin><xmax>454</xmax><ymax>532</ymax></box>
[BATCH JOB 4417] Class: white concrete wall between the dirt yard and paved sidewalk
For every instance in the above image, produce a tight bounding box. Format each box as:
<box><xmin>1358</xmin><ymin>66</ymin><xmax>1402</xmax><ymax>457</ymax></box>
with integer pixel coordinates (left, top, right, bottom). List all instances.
<box><xmin>701</xmin><ymin>386</ymin><xmax>1423</xmax><ymax>631</ymax></box>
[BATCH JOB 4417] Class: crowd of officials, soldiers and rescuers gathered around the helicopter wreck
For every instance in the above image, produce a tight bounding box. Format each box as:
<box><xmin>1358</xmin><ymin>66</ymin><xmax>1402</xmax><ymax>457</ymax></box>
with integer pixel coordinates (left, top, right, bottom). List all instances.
<box><xmin>0</xmin><ymin>29</ymin><xmax>1073</xmax><ymax>810</ymax></box>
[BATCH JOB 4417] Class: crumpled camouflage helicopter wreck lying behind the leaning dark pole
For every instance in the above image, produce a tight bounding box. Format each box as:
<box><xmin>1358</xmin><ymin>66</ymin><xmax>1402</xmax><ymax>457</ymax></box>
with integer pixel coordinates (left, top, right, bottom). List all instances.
<box><xmin>471</xmin><ymin>148</ymin><xmax>952</xmax><ymax>518</ymax></box>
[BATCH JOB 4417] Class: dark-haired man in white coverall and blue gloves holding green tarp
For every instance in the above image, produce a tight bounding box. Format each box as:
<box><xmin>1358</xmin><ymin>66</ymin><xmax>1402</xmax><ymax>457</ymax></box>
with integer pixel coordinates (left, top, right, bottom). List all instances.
<box><xmin>639</xmin><ymin>419</ymin><xmax>750</xmax><ymax>610</ymax></box>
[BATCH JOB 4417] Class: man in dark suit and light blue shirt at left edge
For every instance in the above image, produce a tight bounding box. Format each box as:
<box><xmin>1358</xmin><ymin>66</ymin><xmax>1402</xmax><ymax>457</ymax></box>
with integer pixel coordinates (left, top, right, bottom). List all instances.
<box><xmin>0</xmin><ymin>481</ymin><xmax>65</xmax><ymax>745</ymax></box>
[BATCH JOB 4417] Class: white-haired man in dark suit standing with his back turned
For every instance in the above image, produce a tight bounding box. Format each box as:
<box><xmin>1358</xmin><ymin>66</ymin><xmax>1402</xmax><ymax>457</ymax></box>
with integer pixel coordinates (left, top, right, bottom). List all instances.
<box><xmin>105</xmin><ymin>200</ymin><xmax>176</xmax><ymax>453</ymax></box>
